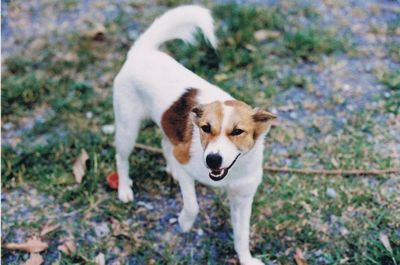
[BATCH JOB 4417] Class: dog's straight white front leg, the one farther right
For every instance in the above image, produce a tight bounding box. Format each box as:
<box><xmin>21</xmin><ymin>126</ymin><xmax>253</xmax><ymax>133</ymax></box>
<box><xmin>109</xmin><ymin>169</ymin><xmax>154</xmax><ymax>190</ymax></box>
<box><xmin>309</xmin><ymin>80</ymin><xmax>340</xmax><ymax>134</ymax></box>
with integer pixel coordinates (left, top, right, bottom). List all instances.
<box><xmin>228</xmin><ymin>189</ymin><xmax>264</xmax><ymax>265</ymax></box>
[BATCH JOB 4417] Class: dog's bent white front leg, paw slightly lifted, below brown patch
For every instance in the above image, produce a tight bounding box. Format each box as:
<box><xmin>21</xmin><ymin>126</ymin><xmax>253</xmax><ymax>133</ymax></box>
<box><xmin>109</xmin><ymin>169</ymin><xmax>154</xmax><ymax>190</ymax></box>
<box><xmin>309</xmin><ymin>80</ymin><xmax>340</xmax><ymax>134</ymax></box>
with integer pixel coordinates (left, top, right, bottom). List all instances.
<box><xmin>178</xmin><ymin>174</ymin><xmax>199</xmax><ymax>232</ymax></box>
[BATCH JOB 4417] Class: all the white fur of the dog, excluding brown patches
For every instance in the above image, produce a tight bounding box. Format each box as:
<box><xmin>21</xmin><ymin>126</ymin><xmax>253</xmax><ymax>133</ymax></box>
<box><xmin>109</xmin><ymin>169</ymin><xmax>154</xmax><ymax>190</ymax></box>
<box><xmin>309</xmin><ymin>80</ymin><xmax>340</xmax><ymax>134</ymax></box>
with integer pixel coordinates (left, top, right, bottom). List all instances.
<box><xmin>114</xmin><ymin>6</ymin><xmax>264</xmax><ymax>264</ymax></box>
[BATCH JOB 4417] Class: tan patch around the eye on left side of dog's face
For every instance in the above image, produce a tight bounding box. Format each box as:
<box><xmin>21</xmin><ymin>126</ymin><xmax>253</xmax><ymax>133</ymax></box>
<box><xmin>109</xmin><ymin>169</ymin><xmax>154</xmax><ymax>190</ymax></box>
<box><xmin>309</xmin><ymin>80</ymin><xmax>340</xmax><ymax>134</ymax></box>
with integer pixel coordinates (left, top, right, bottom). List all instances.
<box><xmin>193</xmin><ymin>101</ymin><xmax>223</xmax><ymax>148</ymax></box>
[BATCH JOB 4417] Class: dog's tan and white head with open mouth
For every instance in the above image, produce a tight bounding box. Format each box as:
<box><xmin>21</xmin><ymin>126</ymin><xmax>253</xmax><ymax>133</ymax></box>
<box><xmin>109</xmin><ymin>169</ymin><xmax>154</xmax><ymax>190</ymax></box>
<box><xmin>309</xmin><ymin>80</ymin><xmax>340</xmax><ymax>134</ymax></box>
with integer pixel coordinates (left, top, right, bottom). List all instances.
<box><xmin>192</xmin><ymin>100</ymin><xmax>276</xmax><ymax>181</ymax></box>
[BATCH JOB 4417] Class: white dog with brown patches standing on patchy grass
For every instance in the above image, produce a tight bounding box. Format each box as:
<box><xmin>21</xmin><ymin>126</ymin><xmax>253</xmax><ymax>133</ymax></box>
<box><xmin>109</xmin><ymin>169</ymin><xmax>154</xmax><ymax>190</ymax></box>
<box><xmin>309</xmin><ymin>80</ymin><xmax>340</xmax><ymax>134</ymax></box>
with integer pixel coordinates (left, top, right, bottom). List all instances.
<box><xmin>113</xmin><ymin>5</ymin><xmax>277</xmax><ymax>265</ymax></box>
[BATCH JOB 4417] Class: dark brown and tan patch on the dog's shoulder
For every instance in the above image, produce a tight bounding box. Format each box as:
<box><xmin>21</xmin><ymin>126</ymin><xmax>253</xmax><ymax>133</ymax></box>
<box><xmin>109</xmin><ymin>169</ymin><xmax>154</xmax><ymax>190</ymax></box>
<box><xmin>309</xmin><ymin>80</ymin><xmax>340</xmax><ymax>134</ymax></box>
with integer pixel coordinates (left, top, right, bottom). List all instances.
<box><xmin>161</xmin><ymin>88</ymin><xmax>197</xmax><ymax>164</ymax></box>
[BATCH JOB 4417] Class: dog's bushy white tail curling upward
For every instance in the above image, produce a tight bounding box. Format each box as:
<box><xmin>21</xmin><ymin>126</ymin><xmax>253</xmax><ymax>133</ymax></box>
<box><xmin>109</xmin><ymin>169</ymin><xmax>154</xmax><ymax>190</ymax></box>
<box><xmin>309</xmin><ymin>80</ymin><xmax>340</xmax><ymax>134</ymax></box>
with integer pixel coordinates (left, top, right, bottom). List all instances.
<box><xmin>133</xmin><ymin>5</ymin><xmax>217</xmax><ymax>49</ymax></box>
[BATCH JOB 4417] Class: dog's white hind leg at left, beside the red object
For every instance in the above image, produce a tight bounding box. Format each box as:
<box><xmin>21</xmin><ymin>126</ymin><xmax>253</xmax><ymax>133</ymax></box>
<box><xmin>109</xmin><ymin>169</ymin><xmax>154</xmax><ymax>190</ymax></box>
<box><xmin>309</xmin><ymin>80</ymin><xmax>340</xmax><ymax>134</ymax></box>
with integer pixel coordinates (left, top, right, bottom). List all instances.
<box><xmin>114</xmin><ymin>79</ymin><xmax>145</xmax><ymax>202</ymax></box>
